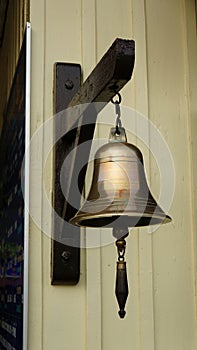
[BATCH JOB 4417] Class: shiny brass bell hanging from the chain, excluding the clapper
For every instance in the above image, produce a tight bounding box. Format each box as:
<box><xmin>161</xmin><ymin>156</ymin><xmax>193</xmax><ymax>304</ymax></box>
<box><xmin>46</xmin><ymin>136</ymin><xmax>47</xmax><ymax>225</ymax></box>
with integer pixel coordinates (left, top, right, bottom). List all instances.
<box><xmin>70</xmin><ymin>128</ymin><xmax>171</xmax><ymax>228</ymax></box>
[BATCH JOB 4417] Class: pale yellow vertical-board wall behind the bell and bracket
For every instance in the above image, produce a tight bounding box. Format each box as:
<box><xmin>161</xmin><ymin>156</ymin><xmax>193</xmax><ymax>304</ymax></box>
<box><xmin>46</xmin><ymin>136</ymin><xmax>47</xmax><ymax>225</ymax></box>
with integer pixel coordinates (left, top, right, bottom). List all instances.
<box><xmin>28</xmin><ymin>0</ymin><xmax>197</xmax><ymax>350</ymax></box>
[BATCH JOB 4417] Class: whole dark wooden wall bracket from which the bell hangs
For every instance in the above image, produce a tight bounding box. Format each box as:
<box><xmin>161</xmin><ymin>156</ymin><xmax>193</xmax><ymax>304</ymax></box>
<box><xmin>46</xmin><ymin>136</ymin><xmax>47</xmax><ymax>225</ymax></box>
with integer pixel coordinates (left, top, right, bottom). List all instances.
<box><xmin>51</xmin><ymin>39</ymin><xmax>135</xmax><ymax>285</ymax></box>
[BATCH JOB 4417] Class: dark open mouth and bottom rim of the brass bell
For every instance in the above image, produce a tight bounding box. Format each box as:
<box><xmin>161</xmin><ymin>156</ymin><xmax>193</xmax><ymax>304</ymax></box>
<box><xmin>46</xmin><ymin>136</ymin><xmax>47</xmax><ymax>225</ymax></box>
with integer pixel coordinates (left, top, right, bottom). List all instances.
<box><xmin>69</xmin><ymin>212</ymin><xmax>172</xmax><ymax>228</ymax></box>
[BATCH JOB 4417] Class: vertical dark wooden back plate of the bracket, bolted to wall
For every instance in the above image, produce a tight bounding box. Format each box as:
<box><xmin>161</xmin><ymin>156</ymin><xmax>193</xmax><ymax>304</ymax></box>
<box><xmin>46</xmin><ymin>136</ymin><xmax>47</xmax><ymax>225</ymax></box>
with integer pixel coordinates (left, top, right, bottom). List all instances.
<box><xmin>51</xmin><ymin>63</ymin><xmax>81</xmax><ymax>285</ymax></box>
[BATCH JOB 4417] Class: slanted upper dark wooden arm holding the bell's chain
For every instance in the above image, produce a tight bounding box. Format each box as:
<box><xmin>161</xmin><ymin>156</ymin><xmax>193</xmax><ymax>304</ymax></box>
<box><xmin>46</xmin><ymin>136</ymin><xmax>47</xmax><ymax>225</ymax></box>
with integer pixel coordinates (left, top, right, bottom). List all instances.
<box><xmin>69</xmin><ymin>39</ymin><xmax>135</xmax><ymax>106</ymax></box>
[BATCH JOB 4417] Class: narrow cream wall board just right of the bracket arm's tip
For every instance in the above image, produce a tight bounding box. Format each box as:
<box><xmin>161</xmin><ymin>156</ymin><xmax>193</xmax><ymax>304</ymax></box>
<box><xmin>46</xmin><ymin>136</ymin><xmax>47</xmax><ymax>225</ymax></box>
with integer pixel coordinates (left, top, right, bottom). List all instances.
<box><xmin>133</xmin><ymin>0</ymin><xmax>155</xmax><ymax>350</ymax></box>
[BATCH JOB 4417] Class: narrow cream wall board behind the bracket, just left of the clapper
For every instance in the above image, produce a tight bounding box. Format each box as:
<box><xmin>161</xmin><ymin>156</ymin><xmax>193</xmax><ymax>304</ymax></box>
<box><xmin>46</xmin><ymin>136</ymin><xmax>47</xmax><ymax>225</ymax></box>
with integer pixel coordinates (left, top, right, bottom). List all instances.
<box><xmin>81</xmin><ymin>0</ymin><xmax>103</xmax><ymax>350</ymax></box>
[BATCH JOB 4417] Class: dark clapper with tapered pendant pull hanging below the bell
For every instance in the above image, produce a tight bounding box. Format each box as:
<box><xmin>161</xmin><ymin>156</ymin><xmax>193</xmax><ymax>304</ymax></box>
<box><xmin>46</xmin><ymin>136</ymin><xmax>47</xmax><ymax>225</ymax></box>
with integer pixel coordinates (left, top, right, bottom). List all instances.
<box><xmin>113</xmin><ymin>229</ymin><xmax>129</xmax><ymax>318</ymax></box>
